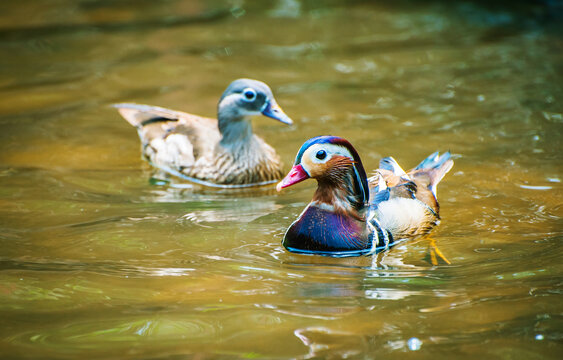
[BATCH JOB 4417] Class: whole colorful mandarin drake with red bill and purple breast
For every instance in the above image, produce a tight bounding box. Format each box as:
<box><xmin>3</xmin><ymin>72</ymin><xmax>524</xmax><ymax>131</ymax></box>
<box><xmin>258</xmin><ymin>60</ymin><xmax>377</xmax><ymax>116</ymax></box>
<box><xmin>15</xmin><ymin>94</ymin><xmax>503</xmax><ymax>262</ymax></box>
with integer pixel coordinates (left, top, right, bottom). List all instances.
<box><xmin>277</xmin><ymin>136</ymin><xmax>453</xmax><ymax>257</ymax></box>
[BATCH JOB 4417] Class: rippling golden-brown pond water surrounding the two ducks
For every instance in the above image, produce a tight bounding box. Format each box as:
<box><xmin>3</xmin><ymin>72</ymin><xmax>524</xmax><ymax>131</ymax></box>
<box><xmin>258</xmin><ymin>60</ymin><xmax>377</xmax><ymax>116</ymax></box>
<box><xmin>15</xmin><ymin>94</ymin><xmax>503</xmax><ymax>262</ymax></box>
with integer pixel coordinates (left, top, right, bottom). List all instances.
<box><xmin>0</xmin><ymin>0</ymin><xmax>563</xmax><ymax>359</ymax></box>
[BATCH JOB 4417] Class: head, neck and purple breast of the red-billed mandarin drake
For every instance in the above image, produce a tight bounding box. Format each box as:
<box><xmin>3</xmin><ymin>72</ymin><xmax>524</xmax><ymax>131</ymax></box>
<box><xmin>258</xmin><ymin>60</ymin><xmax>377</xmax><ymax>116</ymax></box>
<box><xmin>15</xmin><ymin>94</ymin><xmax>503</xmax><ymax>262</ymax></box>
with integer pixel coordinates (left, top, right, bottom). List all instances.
<box><xmin>277</xmin><ymin>136</ymin><xmax>373</xmax><ymax>256</ymax></box>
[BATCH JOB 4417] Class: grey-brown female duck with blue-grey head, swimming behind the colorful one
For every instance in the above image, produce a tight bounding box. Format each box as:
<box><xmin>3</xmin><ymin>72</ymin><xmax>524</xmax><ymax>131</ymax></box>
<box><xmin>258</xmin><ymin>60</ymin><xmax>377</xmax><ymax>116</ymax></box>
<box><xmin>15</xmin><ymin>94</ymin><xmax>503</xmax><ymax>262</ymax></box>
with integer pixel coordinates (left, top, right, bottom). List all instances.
<box><xmin>114</xmin><ymin>79</ymin><xmax>293</xmax><ymax>187</ymax></box>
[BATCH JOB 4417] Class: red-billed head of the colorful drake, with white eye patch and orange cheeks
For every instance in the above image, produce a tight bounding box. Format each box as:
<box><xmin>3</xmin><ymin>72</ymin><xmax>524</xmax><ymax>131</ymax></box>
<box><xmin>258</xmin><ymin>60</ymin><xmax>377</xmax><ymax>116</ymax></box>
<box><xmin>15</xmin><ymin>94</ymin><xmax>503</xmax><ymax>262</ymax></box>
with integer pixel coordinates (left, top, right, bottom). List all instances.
<box><xmin>277</xmin><ymin>136</ymin><xmax>369</xmax><ymax>210</ymax></box>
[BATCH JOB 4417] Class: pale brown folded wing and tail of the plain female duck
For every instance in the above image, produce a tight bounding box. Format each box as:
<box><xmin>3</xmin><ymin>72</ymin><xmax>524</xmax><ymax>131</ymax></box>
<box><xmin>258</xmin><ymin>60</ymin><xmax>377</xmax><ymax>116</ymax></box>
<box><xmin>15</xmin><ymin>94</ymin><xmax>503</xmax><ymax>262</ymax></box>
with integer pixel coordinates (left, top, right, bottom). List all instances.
<box><xmin>114</xmin><ymin>104</ymin><xmax>220</xmax><ymax>172</ymax></box>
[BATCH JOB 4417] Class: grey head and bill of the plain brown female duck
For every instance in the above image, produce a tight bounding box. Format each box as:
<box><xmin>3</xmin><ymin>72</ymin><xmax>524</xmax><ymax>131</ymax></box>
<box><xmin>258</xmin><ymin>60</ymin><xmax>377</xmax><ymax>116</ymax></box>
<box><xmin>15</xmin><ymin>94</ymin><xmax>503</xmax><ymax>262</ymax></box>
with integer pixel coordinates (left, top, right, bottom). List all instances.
<box><xmin>218</xmin><ymin>79</ymin><xmax>293</xmax><ymax>125</ymax></box>
